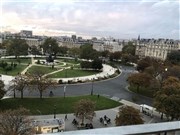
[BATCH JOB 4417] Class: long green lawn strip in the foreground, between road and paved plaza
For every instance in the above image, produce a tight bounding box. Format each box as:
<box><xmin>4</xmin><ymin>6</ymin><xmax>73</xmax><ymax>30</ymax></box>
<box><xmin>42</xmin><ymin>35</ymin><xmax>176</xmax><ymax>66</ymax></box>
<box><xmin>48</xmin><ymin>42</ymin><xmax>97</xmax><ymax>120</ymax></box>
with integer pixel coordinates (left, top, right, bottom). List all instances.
<box><xmin>0</xmin><ymin>95</ymin><xmax>122</xmax><ymax>115</ymax></box>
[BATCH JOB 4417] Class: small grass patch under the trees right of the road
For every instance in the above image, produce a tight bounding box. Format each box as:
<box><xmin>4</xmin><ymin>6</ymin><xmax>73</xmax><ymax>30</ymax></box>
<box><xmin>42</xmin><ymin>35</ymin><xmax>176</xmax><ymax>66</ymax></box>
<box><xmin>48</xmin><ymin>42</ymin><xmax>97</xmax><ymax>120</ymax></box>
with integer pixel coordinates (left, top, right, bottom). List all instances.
<box><xmin>129</xmin><ymin>86</ymin><xmax>155</xmax><ymax>98</ymax></box>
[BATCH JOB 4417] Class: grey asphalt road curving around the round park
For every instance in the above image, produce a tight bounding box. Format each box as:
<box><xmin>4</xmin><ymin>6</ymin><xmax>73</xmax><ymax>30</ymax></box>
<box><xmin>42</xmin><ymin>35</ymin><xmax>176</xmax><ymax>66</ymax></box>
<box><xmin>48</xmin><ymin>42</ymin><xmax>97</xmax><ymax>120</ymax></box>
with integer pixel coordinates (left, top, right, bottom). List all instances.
<box><xmin>14</xmin><ymin>66</ymin><xmax>152</xmax><ymax>105</ymax></box>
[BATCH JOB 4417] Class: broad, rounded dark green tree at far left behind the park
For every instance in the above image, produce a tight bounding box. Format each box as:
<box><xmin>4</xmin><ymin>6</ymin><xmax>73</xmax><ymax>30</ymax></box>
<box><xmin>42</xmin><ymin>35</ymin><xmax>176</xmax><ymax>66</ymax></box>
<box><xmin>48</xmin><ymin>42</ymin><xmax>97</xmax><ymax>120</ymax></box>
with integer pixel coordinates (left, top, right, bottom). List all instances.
<box><xmin>6</xmin><ymin>38</ymin><xmax>29</xmax><ymax>58</ymax></box>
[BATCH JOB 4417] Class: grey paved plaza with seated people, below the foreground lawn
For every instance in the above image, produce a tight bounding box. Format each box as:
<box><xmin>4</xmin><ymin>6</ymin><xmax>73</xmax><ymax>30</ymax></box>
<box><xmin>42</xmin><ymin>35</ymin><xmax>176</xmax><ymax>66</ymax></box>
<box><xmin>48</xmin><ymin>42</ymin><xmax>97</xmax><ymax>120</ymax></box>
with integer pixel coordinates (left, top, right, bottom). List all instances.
<box><xmin>31</xmin><ymin>99</ymin><xmax>160</xmax><ymax>131</ymax></box>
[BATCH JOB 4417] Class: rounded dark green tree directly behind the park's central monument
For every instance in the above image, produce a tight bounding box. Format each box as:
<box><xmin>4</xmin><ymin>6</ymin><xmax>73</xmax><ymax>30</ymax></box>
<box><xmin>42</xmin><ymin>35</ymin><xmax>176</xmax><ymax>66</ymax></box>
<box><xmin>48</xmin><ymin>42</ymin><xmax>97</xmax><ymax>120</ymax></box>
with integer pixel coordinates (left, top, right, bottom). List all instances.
<box><xmin>42</xmin><ymin>37</ymin><xmax>59</xmax><ymax>56</ymax></box>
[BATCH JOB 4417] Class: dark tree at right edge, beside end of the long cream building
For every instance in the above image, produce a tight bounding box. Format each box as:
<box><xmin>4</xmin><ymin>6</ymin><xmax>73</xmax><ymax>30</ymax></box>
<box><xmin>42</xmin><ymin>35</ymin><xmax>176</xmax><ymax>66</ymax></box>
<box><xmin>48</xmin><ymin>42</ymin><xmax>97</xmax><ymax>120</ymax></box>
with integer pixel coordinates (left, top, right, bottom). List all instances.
<box><xmin>167</xmin><ymin>50</ymin><xmax>180</xmax><ymax>64</ymax></box>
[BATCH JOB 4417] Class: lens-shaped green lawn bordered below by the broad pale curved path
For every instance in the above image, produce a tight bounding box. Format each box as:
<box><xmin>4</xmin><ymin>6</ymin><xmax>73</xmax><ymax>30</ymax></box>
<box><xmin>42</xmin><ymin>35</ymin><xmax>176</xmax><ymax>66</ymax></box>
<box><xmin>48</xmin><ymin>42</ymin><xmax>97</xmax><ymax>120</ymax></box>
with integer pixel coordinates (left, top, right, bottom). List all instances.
<box><xmin>49</xmin><ymin>69</ymin><xmax>99</xmax><ymax>78</ymax></box>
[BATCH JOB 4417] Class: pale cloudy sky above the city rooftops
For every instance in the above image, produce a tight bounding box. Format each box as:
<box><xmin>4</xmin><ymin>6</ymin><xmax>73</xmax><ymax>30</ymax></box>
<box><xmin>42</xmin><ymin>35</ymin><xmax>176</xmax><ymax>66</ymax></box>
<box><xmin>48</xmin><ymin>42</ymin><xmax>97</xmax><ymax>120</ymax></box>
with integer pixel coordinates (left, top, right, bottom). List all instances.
<box><xmin>0</xmin><ymin>0</ymin><xmax>180</xmax><ymax>39</ymax></box>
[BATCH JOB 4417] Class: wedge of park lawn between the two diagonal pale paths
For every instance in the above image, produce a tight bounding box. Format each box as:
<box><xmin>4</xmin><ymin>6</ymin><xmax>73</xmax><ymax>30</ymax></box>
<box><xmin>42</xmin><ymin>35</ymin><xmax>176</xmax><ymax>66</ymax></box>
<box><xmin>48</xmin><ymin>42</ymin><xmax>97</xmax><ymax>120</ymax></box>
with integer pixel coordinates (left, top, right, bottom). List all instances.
<box><xmin>27</xmin><ymin>66</ymin><xmax>57</xmax><ymax>74</ymax></box>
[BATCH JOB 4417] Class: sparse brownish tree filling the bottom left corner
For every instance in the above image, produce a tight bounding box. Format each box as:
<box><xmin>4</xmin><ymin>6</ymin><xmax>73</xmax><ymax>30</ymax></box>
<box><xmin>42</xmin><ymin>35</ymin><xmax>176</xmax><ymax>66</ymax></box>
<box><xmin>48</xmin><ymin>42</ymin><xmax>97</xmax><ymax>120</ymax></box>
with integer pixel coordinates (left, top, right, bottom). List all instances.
<box><xmin>0</xmin><ymin>108</ymin><xmax>34</xmax><ymax>135</ymax></box>
